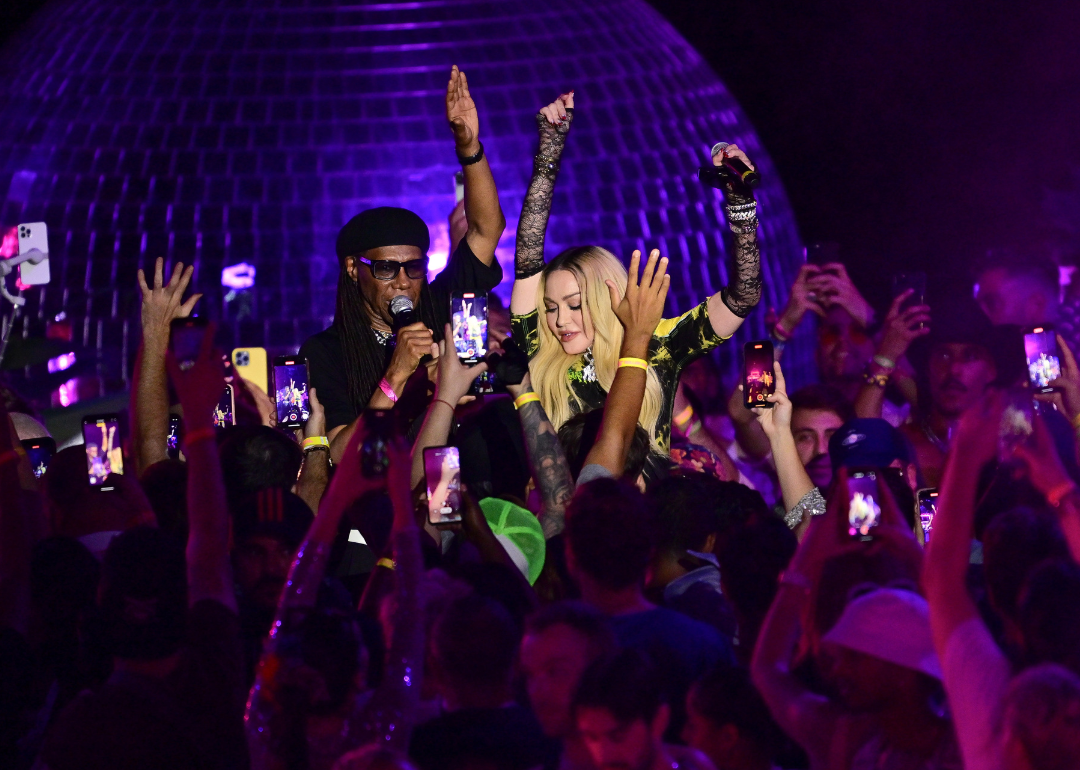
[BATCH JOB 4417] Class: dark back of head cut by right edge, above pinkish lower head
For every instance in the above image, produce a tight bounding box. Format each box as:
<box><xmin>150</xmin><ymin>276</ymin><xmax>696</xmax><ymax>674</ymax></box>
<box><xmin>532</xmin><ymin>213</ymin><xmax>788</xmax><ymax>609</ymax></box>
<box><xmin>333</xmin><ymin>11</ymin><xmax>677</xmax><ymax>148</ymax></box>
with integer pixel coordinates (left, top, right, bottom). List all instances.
<box><xmin>1017</xmin><ymin>558</ymin><xmax>1080</xmax><ymax>673</ymax></box>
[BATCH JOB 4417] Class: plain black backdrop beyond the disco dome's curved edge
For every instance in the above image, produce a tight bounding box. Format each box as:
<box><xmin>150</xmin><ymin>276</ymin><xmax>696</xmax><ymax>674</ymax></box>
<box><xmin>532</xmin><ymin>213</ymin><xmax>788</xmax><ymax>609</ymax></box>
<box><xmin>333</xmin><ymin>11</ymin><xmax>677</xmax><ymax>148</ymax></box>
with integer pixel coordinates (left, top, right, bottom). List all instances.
<box><xmin>0</xmin><ymin>0</ymin><xmax>1080</xmax><ymax>311</ymax></box>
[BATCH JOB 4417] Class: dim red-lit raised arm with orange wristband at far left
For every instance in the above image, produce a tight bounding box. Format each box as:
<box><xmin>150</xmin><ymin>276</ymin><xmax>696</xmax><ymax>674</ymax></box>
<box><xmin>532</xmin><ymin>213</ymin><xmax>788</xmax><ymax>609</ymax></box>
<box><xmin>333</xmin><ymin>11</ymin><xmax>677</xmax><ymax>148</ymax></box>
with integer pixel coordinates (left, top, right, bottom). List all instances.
<box><xmin>166</xmin><ymin>323</ymin><xmax>237</xmax><ymax>612</ymax></box>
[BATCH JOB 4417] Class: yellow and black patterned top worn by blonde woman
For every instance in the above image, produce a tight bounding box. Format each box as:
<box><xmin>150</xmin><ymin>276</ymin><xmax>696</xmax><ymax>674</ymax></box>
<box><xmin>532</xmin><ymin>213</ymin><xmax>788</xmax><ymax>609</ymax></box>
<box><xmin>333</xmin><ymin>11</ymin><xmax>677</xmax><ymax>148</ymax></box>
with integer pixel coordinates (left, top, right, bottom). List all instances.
<box><xmin>511</xmin><ymin>300</ymin><xmax>728</xmax><ymax>451</ymax></box>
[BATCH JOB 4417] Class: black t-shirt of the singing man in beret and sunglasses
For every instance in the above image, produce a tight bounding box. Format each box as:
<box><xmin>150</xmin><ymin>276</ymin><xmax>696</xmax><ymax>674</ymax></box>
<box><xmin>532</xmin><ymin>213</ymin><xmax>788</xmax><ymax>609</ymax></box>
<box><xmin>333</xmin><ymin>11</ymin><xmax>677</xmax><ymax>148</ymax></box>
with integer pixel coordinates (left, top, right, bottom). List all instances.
<box><xmin>300</xmin><ymin>238</ymin><xmax>502</xmax><ymax>431</ymax></box>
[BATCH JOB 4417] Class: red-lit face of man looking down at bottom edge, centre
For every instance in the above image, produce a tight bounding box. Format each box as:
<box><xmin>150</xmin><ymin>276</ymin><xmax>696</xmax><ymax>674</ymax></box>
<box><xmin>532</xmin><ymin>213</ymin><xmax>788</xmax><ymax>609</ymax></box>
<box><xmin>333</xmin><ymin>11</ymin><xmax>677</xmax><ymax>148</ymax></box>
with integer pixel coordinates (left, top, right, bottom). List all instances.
<box><xmin>577</xmin><ymin>706</ymin><xmax>667</xmax><ymax>770</ymax></box>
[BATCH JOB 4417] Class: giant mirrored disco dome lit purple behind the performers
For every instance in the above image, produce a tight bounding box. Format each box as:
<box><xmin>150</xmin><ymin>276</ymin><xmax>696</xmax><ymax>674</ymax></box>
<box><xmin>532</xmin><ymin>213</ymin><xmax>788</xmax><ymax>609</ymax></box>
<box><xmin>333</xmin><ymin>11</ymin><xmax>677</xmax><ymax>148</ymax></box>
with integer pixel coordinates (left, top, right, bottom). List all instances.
<box><xmin>0</xmin><ymin>0</ymin><xmax>809</xmax><ymax>397</ymax></box>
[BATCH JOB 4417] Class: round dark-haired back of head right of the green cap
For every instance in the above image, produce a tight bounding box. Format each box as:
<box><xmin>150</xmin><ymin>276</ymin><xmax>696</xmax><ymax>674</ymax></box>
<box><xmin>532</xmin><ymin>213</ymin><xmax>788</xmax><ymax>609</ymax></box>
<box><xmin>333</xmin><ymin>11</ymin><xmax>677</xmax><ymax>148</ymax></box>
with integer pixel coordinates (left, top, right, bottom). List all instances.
<box><xmin>566</xmin><ymin>478</ymin><xmax>656</xmax><ymax>591</ymax></box>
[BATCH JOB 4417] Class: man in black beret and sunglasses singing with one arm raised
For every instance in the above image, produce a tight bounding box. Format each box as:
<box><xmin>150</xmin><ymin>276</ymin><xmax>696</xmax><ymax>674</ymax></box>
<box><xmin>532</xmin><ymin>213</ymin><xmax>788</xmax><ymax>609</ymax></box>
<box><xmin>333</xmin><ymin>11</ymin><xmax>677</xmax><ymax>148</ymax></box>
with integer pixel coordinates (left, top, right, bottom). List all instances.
<box><xmin>300</xmin><ymin>66</ymin><xmax>507</xmax><ymax>461</ymax></box>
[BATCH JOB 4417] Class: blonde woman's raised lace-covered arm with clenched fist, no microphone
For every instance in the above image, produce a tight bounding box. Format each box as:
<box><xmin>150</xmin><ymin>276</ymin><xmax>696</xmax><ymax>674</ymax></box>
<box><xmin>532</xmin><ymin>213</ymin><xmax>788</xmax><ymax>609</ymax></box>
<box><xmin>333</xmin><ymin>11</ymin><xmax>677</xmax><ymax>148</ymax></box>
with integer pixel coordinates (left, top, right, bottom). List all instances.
<box><xmin>510</xmin><ymin>91</ymin><xmax>573</xmax><ymax>315</ymax></box>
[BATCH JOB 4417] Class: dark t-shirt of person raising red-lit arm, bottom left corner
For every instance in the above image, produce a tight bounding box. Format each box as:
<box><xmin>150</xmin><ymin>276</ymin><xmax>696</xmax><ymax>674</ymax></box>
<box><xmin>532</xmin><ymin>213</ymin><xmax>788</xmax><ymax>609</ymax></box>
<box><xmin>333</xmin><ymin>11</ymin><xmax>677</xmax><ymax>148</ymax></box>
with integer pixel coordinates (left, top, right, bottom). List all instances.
<box><xmin>41</xmin><ymin>599</ymin><xmax>248</xmax><ymax>770</ymax></box>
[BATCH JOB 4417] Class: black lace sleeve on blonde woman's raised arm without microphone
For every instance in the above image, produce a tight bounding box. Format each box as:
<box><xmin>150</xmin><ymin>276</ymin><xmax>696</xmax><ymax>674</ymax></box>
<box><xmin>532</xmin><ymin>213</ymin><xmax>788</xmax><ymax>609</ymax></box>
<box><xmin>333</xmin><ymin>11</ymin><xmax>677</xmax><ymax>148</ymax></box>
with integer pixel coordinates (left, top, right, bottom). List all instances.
<box><xmin>514</xmin><ymin>109</ymin><xmax>573</xmax><ymax>279</ymax></box>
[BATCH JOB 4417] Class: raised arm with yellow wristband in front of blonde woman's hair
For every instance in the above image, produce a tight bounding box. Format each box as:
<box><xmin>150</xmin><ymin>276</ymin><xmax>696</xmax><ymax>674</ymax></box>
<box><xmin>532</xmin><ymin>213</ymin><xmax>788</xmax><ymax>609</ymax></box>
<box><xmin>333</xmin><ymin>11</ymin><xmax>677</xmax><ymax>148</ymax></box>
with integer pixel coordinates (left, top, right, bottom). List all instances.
<box><xmin>584</xmin><ymin>249</ymin><xmax>671</xmax><ymax>477</ymax></box>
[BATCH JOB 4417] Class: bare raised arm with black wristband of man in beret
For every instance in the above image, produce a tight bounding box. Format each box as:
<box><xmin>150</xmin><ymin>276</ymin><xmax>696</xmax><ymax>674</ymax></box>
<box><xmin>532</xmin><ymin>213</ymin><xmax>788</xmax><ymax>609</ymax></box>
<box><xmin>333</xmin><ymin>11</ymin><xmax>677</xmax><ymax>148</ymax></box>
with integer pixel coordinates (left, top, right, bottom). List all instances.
<box><xmin>446</xmin><ymin>65</ymin><xmax>507</xmax><ymax>265</ymax></box>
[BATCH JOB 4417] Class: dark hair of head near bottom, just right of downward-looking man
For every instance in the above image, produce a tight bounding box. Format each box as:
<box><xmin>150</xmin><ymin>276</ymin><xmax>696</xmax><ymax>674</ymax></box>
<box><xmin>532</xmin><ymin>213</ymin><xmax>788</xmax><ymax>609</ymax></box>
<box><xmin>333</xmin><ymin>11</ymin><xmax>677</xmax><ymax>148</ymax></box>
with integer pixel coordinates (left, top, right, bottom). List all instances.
<box><xmin>690</xmin><ymin>664</ymin><xmax>785</xmax><ymax>756</ymax></box>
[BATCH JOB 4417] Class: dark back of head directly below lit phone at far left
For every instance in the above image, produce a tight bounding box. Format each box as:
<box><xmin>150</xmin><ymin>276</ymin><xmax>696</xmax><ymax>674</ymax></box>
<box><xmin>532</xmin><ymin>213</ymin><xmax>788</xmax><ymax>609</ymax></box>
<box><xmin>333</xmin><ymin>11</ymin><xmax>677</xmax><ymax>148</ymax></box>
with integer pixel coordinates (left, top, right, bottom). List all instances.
<box><xmin>42</xmin><ymin>444</ymin><xmax>152</xmax><ymax>538</ymax></box>
